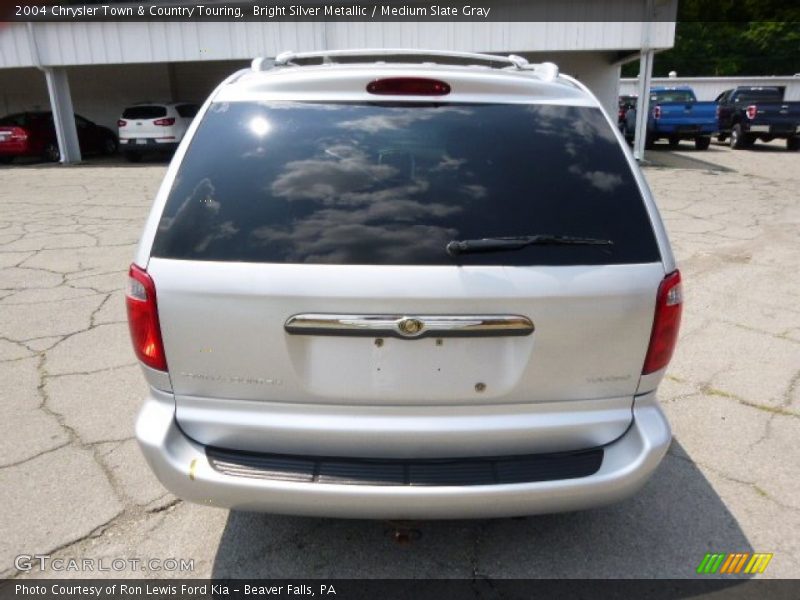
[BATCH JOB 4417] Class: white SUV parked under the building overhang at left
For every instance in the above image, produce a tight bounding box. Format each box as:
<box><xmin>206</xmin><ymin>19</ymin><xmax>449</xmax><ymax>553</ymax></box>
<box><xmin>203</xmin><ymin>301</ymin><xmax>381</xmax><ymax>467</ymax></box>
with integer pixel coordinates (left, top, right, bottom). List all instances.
<box><xmin>117</xmin><ymin>102</ymin><xmax>198</xmax><ymax>162</ymax></box>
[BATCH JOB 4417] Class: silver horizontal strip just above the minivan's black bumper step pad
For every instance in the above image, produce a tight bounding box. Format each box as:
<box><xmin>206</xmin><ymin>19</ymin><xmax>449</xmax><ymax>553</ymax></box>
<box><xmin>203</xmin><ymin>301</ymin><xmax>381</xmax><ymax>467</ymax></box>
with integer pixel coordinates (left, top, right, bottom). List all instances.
<box><xmin>175</xmin><ymin>396</ymin><xmax>633</xmax><ymax>458</ymax></box>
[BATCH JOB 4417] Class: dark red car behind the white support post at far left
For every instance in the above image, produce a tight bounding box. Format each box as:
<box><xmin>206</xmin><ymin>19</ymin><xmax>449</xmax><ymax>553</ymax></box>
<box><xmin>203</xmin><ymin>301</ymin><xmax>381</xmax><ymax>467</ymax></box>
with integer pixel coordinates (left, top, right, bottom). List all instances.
<box><xmin>0</xmin><ymin>112</ymin><xmax>118</xmax><ymax>164</ymax></box>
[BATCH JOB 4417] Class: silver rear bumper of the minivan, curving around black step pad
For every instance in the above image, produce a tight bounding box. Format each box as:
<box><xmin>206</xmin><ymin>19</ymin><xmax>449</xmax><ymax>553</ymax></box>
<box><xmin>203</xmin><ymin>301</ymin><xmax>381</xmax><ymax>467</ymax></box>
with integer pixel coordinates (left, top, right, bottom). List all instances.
<box><xmin>136</xmin><ymin>392</ymin><xmax>671</xmax><ymax>519</ymax></box>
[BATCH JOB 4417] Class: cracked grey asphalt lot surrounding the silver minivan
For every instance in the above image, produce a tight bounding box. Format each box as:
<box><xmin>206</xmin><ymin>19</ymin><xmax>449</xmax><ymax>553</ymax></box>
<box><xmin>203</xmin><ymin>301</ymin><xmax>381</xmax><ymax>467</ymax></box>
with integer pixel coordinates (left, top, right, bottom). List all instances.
<box><xmin>0</xmin><ymin>142</ymin><xmax>800</xmax><ymax>578</ymax></box>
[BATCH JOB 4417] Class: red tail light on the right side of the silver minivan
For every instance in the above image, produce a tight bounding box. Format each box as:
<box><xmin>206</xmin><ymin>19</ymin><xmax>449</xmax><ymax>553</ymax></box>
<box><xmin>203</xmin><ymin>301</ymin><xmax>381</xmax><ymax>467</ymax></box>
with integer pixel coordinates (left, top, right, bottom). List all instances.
<box><xmin>642</xmin><ymin>271</ymin><xmax>683</xmax><ymax>375</ymax></box>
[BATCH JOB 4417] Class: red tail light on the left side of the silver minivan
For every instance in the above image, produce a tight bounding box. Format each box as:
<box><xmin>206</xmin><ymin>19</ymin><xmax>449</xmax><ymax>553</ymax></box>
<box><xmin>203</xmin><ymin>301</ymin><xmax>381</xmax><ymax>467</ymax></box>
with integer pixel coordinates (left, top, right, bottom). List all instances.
<box><xmin>125</xmin><ymin>265</ymin><xmax>167</xmax><ymax>371</ymax></box>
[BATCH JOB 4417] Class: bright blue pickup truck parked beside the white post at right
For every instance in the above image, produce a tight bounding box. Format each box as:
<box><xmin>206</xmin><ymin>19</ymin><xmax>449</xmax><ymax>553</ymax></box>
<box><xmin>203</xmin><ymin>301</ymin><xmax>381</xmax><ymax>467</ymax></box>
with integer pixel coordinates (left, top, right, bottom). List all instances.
<box><xmin>624</xmin><ymin>86</ymin><xmax>717</xmax><ymax>150</ymax></box>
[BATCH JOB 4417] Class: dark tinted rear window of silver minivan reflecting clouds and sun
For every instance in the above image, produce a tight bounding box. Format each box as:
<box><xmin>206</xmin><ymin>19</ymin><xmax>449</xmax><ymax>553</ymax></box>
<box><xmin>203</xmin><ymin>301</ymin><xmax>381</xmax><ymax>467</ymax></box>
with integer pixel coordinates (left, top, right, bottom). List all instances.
<box><xmin>152</xmin><ymin>102</ymin><xmax>660</xmax><ymax>265</ymax></box>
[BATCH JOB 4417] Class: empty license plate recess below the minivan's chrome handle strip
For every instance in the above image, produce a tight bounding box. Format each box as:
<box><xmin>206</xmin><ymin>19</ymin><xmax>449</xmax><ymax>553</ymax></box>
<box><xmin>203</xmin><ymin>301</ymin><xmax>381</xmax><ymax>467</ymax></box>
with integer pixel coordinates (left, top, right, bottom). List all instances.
<box><xmin>287</xmin><ymin>336</ymin><xmax>534</xmax><ymax>405</ymax></box>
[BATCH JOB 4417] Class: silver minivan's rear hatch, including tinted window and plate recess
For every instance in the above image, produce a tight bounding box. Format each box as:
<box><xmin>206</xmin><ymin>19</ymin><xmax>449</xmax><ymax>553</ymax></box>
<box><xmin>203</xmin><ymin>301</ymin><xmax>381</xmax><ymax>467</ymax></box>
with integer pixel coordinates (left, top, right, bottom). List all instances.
<box><xmin>147</xmin><ymin>102</ymin><xmax>664</xmax><ymax>452</ymax></box>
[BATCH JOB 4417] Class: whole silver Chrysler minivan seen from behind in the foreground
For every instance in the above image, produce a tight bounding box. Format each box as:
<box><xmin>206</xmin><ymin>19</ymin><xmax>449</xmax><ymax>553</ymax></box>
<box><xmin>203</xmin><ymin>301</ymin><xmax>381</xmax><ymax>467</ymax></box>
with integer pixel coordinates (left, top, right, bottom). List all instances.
<box><xmin>127</xmin><ymin>50</ymin><xmax>682</xmax><ymax>519</ymax></box>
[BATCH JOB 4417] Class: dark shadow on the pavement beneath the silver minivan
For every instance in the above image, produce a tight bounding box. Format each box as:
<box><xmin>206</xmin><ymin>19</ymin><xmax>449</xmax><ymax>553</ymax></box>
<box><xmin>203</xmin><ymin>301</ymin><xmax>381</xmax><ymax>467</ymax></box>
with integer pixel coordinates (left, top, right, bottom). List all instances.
<box><xmin>212</xmin><ymin>442</ymin><xmax>752</xmax><ymax>579</ymax></box>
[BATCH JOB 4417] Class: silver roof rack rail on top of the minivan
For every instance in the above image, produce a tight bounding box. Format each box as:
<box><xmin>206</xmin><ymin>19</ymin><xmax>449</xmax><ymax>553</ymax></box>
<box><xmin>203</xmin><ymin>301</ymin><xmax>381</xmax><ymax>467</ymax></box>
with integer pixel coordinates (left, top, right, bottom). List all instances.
<box><xmin>251</xmin><ymin>48</ymin><xmax>558</xmax><ymax>81</ymax></box>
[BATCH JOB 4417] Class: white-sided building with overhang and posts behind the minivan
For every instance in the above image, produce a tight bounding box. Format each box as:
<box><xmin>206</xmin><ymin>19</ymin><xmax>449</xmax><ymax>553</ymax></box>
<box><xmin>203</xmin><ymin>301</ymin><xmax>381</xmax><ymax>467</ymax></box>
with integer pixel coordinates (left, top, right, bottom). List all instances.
<box><xmin>0</xmin><ymin>0</ymin><xmax>677</xmax><ymax>162</ymax></box>
